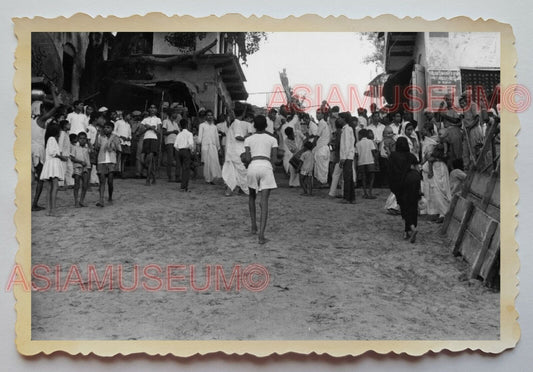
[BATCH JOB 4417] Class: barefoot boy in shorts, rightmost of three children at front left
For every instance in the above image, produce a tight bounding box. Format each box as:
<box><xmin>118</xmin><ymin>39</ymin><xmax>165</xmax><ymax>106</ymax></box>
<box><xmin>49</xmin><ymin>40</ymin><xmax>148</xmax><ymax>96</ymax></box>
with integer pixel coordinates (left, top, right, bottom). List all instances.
<box><xmin>96</xmin><ymin>122</ymin><xmax>120</xmax><ymax>207</ymax></box>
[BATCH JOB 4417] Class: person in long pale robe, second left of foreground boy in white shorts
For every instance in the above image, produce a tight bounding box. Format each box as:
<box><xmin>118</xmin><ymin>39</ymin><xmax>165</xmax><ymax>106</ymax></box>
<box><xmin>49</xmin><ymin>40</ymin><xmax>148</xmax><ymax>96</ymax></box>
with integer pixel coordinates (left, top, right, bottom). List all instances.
<box><xmin>198</xmin><ymin>110</ymin><xmax>222</xmax><ymax>184</ymax></box>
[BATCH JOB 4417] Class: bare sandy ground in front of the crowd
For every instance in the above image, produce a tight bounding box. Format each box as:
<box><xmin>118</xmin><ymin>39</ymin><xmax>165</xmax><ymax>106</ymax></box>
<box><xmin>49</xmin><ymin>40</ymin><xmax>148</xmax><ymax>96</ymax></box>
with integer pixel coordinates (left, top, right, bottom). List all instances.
<box><xmin>32</xmin><ymin>167</ymin><xmax>499</xmax><ymax>340</ymax></box>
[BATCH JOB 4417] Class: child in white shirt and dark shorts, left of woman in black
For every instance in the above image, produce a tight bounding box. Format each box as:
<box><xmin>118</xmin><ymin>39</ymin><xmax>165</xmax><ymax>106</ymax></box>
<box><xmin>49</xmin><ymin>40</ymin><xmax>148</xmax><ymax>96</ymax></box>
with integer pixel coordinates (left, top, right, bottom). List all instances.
<box><xmin>355</xmin><ymin>129</ymin><xmax>376</xmax><ymax>199</ymax></box>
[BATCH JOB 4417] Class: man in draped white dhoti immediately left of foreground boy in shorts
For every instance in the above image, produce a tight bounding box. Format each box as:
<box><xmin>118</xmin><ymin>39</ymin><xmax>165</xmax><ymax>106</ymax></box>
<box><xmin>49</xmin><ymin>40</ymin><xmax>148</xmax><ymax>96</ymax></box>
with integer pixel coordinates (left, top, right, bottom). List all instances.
<box><xmin>222</xmin><ymin>111</ymin><xmax>248</xmax><ymax>196</ymax></box>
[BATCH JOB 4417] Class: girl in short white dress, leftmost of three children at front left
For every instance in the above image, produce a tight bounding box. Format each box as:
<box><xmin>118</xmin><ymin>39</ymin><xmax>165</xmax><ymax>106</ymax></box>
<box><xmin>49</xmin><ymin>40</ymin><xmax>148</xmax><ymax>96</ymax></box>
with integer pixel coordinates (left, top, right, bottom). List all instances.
<box><xmin>40</xmin><ymin>124</ymin><xmax>67</xmax><ymax>217</ymax></box>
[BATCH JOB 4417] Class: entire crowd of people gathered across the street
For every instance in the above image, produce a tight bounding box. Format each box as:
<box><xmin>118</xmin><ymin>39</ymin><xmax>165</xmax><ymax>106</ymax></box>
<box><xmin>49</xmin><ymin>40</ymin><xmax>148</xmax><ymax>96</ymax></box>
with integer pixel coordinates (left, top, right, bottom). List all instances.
<box><xmin>31</xmin><ymin>81</ymin><xmax>499</xmax><ymax>243</ymax></box>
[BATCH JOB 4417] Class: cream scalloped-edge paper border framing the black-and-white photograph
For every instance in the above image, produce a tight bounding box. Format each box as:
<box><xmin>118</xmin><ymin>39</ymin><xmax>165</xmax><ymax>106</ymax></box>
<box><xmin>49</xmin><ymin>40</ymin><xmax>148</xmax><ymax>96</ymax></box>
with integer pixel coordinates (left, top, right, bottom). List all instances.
<box><xmin>13</xmin><ymin>13</ymin><xmax>520</xmax><ymax>357</ymax></box>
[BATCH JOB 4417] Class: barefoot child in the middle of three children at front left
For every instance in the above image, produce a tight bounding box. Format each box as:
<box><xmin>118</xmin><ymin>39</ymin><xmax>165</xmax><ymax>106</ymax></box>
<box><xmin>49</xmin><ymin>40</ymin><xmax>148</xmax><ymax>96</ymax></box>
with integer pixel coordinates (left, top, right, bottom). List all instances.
<box><xmin>70</xmin><ymin>132</ymin><xmax>91</xmax><ymax>208</ymax></box>
